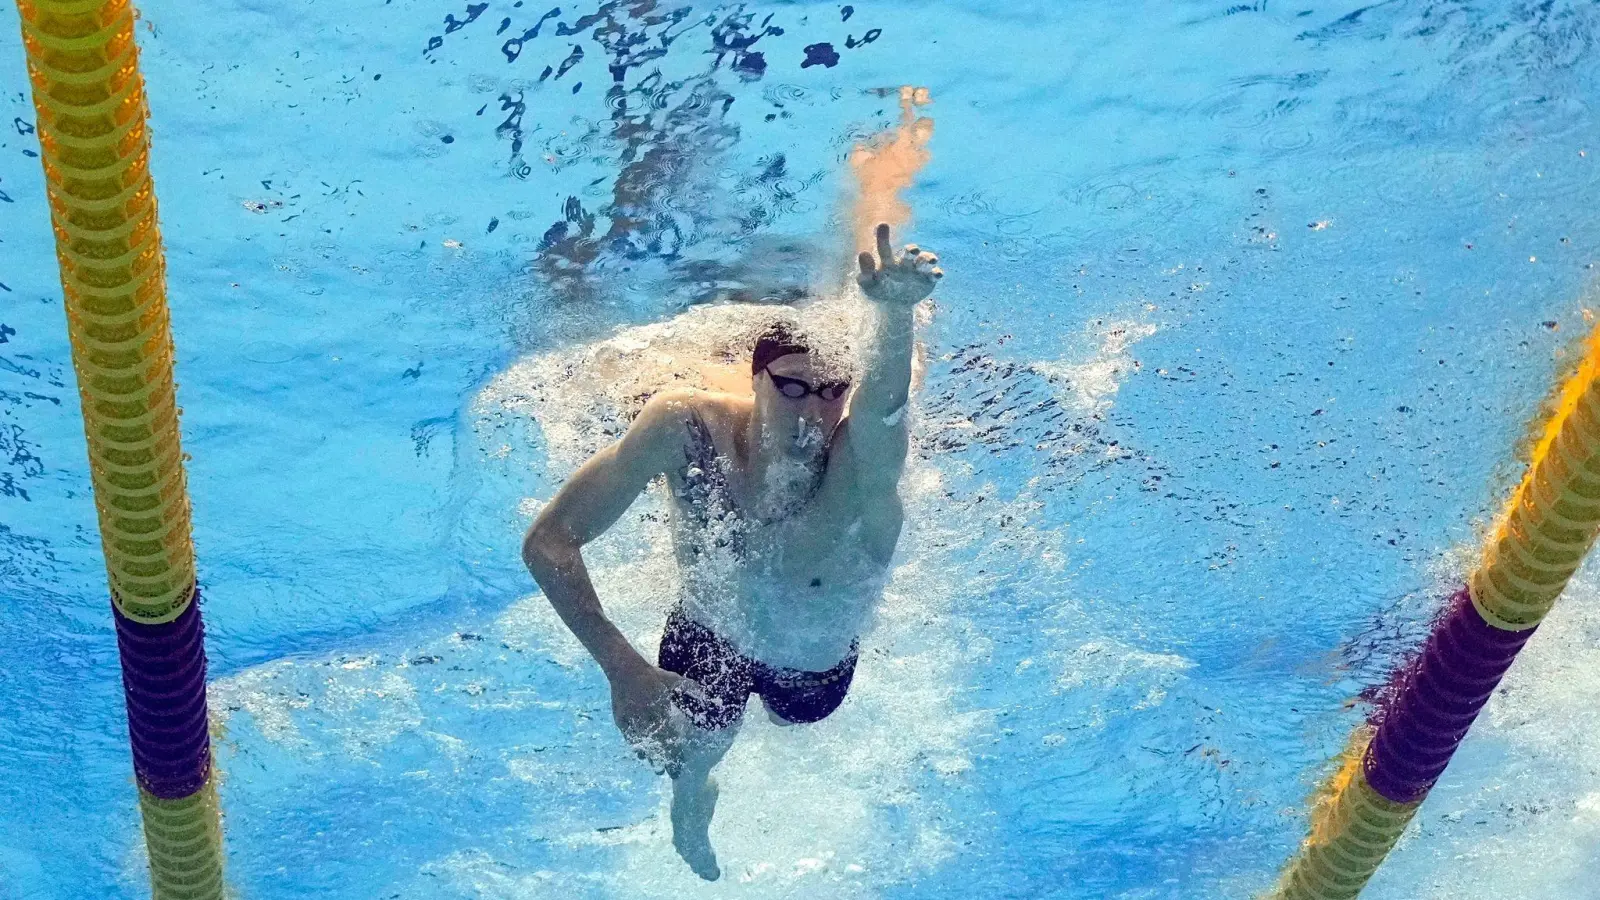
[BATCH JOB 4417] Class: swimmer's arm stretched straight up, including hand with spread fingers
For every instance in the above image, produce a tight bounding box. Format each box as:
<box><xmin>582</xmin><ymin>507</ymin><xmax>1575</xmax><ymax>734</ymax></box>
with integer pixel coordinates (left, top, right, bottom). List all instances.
<box><xmin>845</xmin><ymin>224</ymin><xmax>944</xmax><ymax>487</ymax></box>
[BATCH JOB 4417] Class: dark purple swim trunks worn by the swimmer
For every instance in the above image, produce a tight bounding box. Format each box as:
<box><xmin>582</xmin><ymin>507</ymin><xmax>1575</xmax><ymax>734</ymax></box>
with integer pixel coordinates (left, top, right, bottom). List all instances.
<box><xmin>656</xmin><ymin>609</ymin><xmax>856</xmax><ymax>730</ymax></box>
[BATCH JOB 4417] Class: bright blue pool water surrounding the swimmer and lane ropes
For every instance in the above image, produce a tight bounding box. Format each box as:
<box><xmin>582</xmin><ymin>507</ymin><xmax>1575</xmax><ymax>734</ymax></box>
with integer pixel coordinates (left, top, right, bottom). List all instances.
<box><xmin>0</xmin><ymin>0</ymin><xmax>1600</xmax><ymax>900</ymax></box>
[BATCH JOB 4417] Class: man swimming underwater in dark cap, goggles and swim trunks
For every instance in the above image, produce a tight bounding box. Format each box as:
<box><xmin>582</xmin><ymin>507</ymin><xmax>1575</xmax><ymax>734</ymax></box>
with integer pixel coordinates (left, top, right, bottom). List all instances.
<box><xmin>522</xmin><ymin>224</ymin><xmax>944</xmax><ymax>881</ymax></box>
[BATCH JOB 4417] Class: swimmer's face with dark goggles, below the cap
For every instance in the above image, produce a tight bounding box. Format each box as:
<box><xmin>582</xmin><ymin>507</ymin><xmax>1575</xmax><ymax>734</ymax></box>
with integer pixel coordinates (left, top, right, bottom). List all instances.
<box><xmin>754</xmin><ymin>354</ymin><xmax>850</xmax><ymax>458</ymax></box>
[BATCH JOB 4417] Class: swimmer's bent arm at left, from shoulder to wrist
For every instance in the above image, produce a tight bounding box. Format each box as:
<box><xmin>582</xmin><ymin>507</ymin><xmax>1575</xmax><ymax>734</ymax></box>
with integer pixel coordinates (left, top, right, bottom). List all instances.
<box><xmin>522</xmin><ymin>391</ymin><xmax>693</xmax><ymax>682</ymax></box>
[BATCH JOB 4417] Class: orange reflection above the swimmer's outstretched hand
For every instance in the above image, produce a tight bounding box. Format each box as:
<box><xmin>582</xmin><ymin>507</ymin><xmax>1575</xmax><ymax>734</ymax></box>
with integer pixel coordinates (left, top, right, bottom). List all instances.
<box><xmin>850</xmin><ymin>85</ymin><xmax>933</xmax><ymax>250</ymax></box>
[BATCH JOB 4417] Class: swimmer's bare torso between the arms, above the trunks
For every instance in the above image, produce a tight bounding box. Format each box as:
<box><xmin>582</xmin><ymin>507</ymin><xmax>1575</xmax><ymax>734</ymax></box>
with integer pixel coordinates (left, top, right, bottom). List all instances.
<box><xmin>667</xmin><ymin>394</ymin><xmax>901</xmax><ymax>671</ymax></box>
